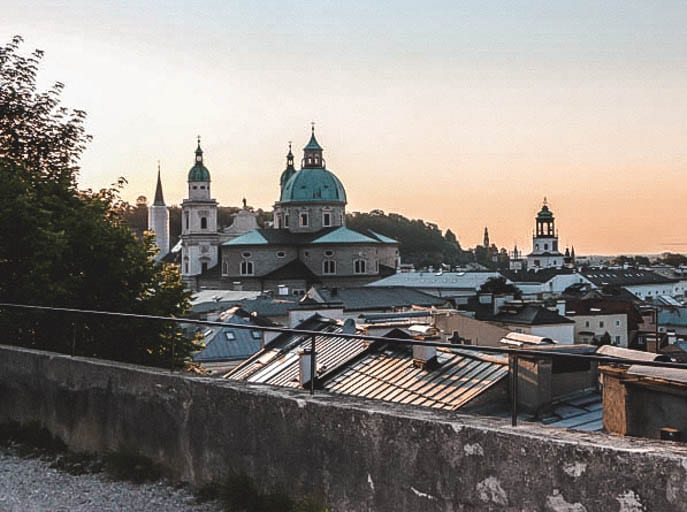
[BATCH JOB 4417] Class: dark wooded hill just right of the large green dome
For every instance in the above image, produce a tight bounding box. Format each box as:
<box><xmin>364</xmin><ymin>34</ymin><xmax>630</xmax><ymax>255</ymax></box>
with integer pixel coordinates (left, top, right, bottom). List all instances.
<box><xmin>346</xmin><ymin>210</ymin><xmax>472</xmax><ymax>268</ymax></box>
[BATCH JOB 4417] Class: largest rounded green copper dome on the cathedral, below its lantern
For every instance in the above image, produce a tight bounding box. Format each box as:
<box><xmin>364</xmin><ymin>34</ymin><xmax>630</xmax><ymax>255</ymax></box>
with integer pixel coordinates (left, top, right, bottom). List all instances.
<box><xmin>280</xmin><ymin>168</ymin><xmax>346</xmax><ymax>204</ymax></box>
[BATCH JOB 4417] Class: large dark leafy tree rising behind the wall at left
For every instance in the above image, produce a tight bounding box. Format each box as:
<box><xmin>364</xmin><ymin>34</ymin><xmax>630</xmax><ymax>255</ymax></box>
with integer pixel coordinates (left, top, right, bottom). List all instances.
<box><xmin>0</xmin><ymin>37</ymin><xmax>194</xmax><ymax>365</ymax></box>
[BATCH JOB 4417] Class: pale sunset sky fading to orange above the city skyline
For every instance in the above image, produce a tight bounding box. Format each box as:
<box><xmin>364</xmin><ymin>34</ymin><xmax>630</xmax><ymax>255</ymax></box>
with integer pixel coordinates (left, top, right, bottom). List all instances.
<box><xmin>0</xmin><ymin>0</ymin><xmax>687</xmax><ymax>255</ymax></box>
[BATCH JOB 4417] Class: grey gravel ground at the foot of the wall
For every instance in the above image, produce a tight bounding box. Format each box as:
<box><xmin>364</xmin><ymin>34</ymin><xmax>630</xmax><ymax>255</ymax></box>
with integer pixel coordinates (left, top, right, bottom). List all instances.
<box><xmin>0</xmin><ymin>449</ymin><xmax>222</xmax><ymax>512</ymax></box>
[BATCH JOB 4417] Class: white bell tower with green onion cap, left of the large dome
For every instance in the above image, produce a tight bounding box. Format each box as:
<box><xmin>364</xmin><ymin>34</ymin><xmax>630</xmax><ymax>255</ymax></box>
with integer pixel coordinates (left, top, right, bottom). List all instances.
<box><xmin>181</xmin><ymin>137</ymin><xmax>219</xmax><ymax>278</ymax></box>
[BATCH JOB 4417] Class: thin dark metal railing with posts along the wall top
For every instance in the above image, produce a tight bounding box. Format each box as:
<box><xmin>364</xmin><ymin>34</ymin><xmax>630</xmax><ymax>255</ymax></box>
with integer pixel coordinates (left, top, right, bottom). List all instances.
<box><xmin>0</xmin><ymin>303</ymin><xmax>687</xmax><ymax>426</ymax></box>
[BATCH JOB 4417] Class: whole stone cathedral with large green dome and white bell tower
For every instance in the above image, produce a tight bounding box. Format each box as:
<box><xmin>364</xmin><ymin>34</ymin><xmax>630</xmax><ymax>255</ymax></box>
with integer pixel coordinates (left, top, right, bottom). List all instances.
<box><xmin>169</xmin><ymin>128</ymin><xmax>400</xmax><ymax>295</ymax></box>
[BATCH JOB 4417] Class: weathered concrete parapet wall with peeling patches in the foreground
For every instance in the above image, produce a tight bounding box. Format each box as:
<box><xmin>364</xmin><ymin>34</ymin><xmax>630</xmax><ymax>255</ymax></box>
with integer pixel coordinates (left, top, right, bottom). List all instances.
<box><xmin>0</xmin><ymin>346</ymin><xmax>687</xmax><ymax>512</ymax></box>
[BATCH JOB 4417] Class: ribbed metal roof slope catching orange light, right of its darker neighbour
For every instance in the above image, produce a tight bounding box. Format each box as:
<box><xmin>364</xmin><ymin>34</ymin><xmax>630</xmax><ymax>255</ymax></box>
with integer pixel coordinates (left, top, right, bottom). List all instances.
<box><xmin>324</xmin><ymin>345</ymin><xmax>508</xmax><ymax>410</ymax></box>
